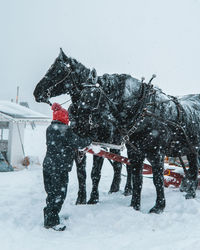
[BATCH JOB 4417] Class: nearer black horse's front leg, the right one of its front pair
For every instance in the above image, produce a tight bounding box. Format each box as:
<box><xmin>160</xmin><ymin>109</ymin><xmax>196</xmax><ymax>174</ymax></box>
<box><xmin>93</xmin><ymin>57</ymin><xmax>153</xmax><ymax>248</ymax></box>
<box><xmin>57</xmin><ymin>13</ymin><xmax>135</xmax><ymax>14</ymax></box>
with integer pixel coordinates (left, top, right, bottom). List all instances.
<box><xmin>148</xmin><ymin>154</ymin><xmax>165</xmax><ymax>214</ymax></box>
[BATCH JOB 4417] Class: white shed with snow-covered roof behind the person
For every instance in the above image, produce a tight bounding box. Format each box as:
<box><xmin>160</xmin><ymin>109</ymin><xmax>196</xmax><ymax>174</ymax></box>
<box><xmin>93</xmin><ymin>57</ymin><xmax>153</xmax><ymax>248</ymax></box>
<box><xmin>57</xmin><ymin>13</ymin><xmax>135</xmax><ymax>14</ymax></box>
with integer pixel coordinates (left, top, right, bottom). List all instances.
<box><xmin>0</xmin><ymin>101</ymin><xmax>51</xmax><ymax>171</ymax></box>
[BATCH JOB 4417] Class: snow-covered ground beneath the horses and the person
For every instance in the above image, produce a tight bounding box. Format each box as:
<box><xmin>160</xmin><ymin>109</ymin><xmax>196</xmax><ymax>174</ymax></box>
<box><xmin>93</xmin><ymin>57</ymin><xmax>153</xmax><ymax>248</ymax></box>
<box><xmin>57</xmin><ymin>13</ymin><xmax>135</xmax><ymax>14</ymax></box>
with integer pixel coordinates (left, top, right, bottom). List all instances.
<box><xmin>0</xmin><ymin>127</ymin><xmax>200</xmax><ymax>250</ymax></box>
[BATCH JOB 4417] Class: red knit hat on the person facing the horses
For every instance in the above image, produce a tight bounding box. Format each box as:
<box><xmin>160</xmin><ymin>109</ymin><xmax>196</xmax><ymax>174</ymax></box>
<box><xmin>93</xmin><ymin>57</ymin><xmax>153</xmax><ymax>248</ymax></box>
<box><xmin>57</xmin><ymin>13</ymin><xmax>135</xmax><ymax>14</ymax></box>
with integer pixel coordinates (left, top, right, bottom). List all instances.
<box><xmin>51</xmin><ymin>102</ymin><xmax>69</xmax><ymax>125</ymax></box>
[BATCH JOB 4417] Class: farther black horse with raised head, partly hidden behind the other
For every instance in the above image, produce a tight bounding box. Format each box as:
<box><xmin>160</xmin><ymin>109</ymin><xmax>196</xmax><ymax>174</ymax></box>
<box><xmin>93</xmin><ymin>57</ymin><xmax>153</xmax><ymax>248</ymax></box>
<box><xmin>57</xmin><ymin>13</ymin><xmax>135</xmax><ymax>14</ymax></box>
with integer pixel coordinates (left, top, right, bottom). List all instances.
<box><xmin>34</xmin><ymin>50</ymin><xmax>132</xmax><ymax>204</ymax></box>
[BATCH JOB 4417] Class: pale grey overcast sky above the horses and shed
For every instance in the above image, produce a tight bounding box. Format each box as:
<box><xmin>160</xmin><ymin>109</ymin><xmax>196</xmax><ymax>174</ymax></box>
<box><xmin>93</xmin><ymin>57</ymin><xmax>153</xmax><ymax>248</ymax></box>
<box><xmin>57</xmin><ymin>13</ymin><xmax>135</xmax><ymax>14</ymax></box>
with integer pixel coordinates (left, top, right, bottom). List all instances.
<box><xmin>0</xmin><ymin>0</ymin><xmax>200</xmax><ymax>113</ymax></box>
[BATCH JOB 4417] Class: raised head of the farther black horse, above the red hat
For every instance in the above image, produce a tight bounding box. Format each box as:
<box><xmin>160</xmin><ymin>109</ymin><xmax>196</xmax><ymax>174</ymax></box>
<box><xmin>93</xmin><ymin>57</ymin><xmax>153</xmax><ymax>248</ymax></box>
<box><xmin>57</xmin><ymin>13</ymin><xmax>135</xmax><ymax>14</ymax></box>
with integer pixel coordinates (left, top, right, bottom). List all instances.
<box><xmin>33</xmin><ymin>49</ymin><xmax>90</xmax><ymax>103</ymax></box>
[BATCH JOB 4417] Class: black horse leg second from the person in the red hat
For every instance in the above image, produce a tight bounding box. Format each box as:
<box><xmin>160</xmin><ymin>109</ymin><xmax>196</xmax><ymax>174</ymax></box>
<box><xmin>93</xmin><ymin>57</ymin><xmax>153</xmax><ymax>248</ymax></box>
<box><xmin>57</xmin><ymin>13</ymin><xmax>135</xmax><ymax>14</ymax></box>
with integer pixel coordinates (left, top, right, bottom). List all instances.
<box><xmin>87</xmin><ymin>155</ymin><xmax>104</xmax><ymax>204</ymax></box>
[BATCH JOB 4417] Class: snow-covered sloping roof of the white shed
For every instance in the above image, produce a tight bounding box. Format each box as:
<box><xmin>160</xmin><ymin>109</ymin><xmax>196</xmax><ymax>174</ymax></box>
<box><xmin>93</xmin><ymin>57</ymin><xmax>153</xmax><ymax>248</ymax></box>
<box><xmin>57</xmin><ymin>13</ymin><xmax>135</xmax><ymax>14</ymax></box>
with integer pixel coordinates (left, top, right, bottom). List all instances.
<box><xmin>0</xmin><ymin>101</ymin><xmax>51</xmax><ymax>122</ymax></box>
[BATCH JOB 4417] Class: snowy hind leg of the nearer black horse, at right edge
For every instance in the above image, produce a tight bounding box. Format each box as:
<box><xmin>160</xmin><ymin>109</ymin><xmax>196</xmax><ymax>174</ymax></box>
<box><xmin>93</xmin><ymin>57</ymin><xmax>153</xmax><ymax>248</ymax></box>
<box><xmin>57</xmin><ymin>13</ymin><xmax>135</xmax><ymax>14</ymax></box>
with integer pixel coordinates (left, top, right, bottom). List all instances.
<box><xmin>180</xmin><ymin>153</ymin><xmax>199</xmax><ymax>199</ymax></box>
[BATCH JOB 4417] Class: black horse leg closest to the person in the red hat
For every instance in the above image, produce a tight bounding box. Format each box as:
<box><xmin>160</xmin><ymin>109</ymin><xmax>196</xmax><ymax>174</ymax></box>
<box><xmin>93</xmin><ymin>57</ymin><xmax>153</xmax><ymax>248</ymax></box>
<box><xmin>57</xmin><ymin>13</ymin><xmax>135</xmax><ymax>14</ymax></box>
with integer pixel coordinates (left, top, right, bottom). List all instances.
<box><xmin>75</xmin><ymin>154</ymin><xmax>86</xmax><ymax>205</ymax></box>
